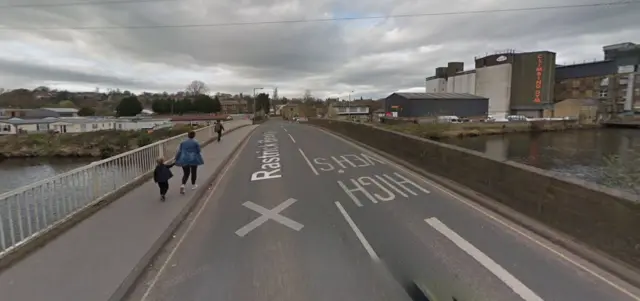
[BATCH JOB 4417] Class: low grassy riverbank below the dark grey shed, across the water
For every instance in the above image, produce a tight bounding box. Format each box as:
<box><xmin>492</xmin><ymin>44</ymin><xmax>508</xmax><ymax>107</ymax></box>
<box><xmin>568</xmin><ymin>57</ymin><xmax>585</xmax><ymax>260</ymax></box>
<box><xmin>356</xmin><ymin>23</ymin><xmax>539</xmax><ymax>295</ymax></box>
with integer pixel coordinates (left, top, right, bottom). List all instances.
<box><xmin>382</xmin><ymin>121</ymin><xmax>600</xmax><ymax>140</ymax></box>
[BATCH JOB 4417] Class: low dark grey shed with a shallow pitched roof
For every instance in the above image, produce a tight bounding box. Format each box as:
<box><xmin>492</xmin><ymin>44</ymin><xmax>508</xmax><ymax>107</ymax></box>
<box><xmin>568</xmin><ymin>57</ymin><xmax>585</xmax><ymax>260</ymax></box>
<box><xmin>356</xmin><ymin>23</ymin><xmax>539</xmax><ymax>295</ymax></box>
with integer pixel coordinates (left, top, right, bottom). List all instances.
<box><xmin>385</xmin><ymin>93</ymin><xmax>489</xmax><ymax>117</ymax></box>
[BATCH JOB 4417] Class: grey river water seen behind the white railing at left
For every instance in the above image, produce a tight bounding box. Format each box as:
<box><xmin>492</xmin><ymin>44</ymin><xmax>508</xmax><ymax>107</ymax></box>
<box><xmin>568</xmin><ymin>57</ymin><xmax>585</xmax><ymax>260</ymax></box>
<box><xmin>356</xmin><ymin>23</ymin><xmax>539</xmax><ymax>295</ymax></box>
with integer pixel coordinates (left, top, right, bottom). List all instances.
<box><xmin>0</xmin><ymin>158</ymin><xmax>93</xmax><ymax>194</ymax></box>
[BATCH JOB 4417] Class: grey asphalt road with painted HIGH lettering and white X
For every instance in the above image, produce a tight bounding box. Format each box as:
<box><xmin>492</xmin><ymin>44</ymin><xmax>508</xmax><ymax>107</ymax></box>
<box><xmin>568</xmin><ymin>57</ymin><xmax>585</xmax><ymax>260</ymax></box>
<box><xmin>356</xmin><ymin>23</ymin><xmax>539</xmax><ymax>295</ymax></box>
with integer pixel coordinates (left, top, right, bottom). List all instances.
<box><xmin>130</xmin><ymin>121</ymin><xmax>640</xmax><ymax>301</ymax></box>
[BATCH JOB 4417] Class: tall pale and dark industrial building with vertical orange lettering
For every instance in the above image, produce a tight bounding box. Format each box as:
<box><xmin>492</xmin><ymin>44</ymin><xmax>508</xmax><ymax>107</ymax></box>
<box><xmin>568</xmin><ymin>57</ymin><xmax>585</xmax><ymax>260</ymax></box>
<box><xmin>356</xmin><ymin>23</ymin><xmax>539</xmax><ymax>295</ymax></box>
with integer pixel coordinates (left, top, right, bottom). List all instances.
<box><xmin>425</xmin><ymin>51</ymin><xmax>556</xmax><ymax>118</ymax></box>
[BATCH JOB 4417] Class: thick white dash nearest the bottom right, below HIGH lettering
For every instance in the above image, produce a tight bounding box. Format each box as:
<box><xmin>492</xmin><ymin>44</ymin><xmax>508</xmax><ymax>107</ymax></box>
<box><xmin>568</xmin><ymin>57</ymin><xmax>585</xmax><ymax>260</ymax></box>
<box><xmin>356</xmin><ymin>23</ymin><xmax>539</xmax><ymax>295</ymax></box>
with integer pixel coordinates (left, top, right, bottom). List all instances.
<box><xmin>424</xmin><ymin>217</ymin><xmax>543</xmax><ymax>301</ymax></box>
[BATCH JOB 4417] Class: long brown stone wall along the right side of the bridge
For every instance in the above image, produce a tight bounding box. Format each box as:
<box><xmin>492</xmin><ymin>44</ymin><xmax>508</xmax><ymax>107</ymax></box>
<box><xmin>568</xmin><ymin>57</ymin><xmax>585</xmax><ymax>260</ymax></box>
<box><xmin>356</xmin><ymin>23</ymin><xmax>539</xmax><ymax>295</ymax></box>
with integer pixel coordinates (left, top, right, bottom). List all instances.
<box><xmin>309</xmin><ymin>119</ymin><xmax>640</xmax><ymax>268</ymax></box>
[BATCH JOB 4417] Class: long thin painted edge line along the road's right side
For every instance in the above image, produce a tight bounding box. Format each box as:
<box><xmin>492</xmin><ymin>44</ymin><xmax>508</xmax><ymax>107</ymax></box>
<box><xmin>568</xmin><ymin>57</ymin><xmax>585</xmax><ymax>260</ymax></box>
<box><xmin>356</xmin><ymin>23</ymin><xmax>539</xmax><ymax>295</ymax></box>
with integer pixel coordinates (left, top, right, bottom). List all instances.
<box><xmin>320</xmin><ymin>126</ymin><xmax>640</xmax><ymax>301</ymax></box>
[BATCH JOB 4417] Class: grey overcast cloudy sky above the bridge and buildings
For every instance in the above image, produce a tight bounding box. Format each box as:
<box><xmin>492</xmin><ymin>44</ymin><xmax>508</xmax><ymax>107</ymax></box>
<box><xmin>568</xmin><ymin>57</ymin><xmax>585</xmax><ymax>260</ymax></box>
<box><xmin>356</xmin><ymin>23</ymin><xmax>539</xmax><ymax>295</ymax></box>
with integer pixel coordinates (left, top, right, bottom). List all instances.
<box><xmin>0</xmin><ymin>0</ymin><xmax>640</xmax><ymax>98</ymax></box>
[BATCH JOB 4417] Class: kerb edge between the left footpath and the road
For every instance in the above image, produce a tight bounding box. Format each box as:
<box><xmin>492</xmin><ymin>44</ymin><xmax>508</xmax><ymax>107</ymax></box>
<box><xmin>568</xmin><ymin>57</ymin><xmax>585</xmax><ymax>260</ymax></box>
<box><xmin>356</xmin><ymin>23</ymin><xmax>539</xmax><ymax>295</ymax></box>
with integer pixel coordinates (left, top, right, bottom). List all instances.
<box><xmin>109</xmin><ymin>124</ymin><xmax>255</xmax><ymax>301</ymax></box>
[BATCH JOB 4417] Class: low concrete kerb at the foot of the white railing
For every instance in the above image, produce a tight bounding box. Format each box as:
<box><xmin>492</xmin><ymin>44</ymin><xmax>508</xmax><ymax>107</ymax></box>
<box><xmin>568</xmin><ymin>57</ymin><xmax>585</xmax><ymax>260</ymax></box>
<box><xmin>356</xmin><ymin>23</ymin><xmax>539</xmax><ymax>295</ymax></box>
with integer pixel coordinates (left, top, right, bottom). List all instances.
<box><xmin>0</xmin><ymin>124</ymin><xmax>249</xmax><ymax>273</ymax></box>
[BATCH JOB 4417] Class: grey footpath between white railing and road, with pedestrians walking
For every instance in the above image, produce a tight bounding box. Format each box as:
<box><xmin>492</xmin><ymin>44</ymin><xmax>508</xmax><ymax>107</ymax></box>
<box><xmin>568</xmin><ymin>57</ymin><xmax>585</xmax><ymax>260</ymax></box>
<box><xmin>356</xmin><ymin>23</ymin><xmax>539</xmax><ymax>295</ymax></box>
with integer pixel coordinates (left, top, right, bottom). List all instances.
<box><xmin>0</xmin><ymin>126</ymin><xmax>256</xmax><ymax>301</ymax></box>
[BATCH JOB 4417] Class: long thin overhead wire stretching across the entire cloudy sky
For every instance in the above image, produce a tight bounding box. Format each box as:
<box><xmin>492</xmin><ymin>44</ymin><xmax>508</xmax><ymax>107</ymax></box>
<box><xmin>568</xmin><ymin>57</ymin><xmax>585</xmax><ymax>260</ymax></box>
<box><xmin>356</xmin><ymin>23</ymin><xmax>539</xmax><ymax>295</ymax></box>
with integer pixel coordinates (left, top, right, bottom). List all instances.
<box><xmin>0</xmin><ymin>0</ymin><xmax>640</xmax><ymax>31</ymax></box>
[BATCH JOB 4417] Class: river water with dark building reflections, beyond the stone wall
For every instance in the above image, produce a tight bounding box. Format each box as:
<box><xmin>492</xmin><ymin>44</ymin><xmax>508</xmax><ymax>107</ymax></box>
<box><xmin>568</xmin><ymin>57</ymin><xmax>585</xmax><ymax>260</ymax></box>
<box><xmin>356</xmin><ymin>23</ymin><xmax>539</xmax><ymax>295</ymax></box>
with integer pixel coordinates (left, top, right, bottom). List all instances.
<box><xmin>446</xmin><ymin>129</ymin><xmax>640</xmax><ymax>183</ymax></box>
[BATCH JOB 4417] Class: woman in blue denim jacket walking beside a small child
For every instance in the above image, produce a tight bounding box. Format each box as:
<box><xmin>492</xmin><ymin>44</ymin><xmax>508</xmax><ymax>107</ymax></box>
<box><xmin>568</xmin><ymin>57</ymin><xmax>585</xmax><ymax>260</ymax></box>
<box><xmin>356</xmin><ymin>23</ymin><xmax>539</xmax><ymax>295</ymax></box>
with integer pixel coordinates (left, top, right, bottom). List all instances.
<box><xmin>176</xmin><ymin>131</ymin><xmax>204</xmax><ymax>194</ymax></box>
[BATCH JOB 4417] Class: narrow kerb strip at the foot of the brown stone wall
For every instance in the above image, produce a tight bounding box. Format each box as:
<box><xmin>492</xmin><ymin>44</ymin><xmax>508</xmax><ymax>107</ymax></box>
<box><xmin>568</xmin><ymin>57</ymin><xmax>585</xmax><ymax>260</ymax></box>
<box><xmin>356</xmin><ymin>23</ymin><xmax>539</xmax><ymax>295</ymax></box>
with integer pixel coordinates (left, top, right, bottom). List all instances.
<box><xmin>308</xmin><ymin>124</ymin><xmax>640</xmax><ymax>288</ymax></box>
